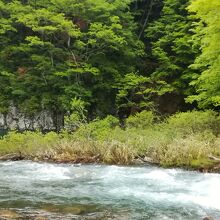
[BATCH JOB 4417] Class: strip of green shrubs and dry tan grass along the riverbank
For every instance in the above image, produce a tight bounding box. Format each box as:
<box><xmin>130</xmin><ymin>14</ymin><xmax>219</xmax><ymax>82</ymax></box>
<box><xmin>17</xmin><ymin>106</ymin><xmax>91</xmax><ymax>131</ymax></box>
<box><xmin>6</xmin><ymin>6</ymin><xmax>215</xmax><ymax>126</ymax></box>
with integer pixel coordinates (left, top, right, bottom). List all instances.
<box><xmin>0</xmin><ymin>111</ymin><xmax>220</xmax><ymax>171</ymax></box>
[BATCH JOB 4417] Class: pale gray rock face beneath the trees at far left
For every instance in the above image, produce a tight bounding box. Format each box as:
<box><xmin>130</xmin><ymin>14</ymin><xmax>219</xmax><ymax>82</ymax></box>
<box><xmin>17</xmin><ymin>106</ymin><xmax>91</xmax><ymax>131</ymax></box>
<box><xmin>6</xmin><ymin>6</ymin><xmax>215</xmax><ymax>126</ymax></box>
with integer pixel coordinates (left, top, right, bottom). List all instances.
<box><xmin>0</xmin><ymin>106</ymin><xmax>56</xmax><ymax>130</ymax></box>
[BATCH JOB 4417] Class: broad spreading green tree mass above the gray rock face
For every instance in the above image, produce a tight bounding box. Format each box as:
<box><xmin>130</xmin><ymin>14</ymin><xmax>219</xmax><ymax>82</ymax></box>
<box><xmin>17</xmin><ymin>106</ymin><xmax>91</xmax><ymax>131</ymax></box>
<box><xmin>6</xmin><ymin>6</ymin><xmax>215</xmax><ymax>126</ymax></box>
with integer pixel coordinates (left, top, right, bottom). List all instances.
<box><xmin>0</xmin><ymin>0</ymin><xmax>143</xmax><ymax>127</ymax></box>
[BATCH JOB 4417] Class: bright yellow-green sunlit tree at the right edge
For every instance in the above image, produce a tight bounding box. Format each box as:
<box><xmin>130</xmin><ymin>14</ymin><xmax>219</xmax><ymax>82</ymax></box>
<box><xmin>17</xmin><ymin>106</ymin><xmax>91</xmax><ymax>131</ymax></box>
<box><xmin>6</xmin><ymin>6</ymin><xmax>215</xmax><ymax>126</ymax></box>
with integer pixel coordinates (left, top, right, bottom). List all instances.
<box><xmin>187</xmin><ymin>0</ymin><xmax>220</xmax><ymax>108</ymax></box>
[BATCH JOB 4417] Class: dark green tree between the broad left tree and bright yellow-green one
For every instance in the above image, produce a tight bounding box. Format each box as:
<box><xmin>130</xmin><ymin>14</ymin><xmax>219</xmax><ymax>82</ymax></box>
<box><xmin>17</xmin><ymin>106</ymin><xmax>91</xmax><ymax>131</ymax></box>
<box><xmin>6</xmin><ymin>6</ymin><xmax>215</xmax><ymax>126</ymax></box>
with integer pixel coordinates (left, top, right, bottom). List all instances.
<box><xmin>145</xmin><ymin>0</ymin><xmax>198</xmax><ymax>113</ymax></box>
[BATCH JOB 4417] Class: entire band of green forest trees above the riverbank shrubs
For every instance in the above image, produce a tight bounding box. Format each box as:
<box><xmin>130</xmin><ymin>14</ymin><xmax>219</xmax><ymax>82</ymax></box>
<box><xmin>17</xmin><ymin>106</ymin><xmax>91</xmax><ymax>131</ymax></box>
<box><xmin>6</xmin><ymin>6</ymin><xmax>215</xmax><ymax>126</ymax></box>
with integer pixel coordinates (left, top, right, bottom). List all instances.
<box><xmin>0</xmin><ymin>0</ymin><xmax>220</xmax><ymax>130</ymax></box>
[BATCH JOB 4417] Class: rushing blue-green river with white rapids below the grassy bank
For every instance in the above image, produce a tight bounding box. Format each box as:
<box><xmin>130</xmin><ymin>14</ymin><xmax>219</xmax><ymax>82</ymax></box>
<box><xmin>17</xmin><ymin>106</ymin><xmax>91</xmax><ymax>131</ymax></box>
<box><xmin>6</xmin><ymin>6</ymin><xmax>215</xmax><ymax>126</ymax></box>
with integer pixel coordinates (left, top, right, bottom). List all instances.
<box><xmin>0</xmin><ymin>161</ymin><xmax>220</xmax><ymax>220</ymax></box>
